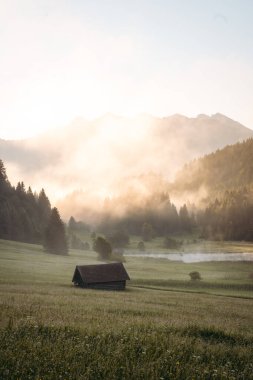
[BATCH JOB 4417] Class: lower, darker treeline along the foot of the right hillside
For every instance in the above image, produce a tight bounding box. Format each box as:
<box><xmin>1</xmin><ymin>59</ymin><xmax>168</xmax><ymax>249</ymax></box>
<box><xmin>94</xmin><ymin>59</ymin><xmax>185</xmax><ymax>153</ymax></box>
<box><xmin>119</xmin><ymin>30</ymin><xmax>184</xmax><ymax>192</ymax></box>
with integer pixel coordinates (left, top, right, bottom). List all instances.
<box><xmin>91</xmin><ymin>186</ymin><xmax>253</xmax><ymax>241</ymax></box>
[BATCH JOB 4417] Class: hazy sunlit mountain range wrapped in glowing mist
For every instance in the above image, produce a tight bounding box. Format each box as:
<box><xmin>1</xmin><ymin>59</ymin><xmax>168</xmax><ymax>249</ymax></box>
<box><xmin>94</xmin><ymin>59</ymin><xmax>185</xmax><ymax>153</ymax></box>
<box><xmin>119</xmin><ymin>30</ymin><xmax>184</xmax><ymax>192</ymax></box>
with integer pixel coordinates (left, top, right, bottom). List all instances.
<box><xmin>0</xmin><ymin>114</ymin><xmax>253</xmax><ymax>217</ymax></box>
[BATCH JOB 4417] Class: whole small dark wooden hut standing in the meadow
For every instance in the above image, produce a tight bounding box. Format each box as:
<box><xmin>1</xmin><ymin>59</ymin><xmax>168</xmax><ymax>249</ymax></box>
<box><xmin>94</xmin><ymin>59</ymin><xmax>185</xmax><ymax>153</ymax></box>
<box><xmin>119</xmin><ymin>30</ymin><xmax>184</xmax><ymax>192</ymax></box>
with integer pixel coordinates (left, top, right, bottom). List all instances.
<box><xmin>72</xmin><ymin>263</ymin><xmax>130</xmax><ymax>290</ymax></box>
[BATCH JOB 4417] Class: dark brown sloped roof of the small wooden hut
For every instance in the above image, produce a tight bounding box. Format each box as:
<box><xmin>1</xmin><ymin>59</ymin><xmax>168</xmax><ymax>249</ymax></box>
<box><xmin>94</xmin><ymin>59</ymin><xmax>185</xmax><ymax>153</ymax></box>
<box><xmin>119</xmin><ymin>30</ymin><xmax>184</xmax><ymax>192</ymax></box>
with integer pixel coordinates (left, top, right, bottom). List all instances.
<box><xmin>72</xmin><ymin>263</ymin><xmax>130</xmax><ymax>284</ymax></box>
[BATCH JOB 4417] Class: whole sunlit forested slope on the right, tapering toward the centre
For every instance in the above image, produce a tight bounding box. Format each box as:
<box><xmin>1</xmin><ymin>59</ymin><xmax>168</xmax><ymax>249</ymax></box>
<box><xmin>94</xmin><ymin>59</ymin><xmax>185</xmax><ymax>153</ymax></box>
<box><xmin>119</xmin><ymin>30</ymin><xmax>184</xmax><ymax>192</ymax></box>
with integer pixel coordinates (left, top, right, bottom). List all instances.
<box><xmin>93</xmin><ymin>139</ymin><xmax>253</xmax><ymax>241</ymax></box>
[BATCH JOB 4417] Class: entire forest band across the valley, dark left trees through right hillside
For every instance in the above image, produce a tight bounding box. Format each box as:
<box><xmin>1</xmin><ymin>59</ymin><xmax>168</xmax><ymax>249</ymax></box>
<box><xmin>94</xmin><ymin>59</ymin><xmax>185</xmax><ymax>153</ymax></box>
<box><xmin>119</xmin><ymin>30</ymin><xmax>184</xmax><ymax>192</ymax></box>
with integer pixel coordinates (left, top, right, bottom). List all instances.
<box><xmin>0</xmin><ymin>139</ymin><xmax>253</xmax><ymax>246</ymax></box>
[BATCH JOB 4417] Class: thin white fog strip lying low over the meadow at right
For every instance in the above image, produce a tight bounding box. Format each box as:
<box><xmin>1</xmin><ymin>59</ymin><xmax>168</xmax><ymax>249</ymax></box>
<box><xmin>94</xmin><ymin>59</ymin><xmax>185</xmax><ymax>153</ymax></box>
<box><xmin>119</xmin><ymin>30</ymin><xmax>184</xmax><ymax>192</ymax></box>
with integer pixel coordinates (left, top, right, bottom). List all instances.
<box><xmin>124</xmin><ymin>250</ymin><xmax>253</xmax><ymax>263</ymax></box>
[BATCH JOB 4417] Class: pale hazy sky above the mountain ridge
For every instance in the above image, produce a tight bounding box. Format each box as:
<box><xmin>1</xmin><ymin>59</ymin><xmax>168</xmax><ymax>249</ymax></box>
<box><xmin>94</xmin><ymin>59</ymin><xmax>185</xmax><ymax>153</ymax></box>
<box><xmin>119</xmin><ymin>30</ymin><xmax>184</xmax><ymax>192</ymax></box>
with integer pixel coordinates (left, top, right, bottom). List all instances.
<box><xmin>0</xmin><ymin>0</ymin><xmax>253</xmax><ymax>138</ymax></box>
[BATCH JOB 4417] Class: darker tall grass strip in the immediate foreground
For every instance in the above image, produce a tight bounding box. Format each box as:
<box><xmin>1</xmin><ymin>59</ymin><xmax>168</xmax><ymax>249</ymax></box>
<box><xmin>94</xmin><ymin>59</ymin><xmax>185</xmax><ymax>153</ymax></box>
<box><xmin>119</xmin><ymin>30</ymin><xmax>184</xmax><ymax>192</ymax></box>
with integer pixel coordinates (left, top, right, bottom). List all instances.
<box><xmin>0</xmin><ymin>325</ymin><xmax>253</xmax><ymax>380</ymax></box>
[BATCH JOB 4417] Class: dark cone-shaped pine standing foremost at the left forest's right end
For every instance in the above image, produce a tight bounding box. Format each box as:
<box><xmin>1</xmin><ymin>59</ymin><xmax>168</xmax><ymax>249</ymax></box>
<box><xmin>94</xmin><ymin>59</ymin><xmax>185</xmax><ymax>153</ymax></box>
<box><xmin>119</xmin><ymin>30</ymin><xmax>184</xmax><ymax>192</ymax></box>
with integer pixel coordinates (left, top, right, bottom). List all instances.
<box><xmin>44</xmin><ymin>207</ymin><xmax>68</xmax><ymax>255</ymax></box>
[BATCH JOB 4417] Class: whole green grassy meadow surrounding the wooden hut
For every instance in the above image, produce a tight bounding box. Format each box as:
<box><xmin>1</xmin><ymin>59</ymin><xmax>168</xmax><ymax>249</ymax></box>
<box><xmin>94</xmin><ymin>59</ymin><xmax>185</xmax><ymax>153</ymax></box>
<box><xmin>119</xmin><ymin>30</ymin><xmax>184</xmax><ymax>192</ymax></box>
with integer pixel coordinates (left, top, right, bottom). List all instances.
<box><xmin>0</xmin><ymin>240</ymin><xmax>253</xmax><ymax>380</ymax></box>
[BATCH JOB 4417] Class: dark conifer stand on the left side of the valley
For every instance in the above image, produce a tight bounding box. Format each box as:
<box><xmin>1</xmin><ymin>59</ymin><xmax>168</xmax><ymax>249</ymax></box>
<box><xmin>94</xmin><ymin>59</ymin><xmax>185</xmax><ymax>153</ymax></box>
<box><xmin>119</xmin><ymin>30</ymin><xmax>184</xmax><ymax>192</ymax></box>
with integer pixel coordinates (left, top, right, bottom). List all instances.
<box><xmin>0</xmin><ymin>160</ymin><xmax>67</xmax><ymax>254</ymax></box>
